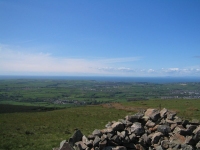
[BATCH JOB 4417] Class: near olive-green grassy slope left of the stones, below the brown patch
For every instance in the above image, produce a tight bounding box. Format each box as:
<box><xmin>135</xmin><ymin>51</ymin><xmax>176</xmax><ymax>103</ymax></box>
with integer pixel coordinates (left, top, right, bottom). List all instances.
<box><xmin>0</xmin><ymin>106</ymin><xmax>128</xmax><ymax>150</ymax></box>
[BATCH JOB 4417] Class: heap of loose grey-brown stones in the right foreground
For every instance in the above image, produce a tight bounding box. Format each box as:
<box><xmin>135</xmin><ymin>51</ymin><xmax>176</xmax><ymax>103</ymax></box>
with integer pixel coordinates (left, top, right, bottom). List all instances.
<box><xmin>53</xmin><ymin>108</ymin><xmax>200</xmax><ymax>150</ymax></box>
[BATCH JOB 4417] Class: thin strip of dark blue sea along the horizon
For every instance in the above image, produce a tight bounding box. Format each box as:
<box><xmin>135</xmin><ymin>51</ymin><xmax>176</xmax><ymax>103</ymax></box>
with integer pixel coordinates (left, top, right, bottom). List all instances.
<box><xmin>0</xmin><ymin>76</ymin><xmax>200</xmax><ymax>83</ymax></box>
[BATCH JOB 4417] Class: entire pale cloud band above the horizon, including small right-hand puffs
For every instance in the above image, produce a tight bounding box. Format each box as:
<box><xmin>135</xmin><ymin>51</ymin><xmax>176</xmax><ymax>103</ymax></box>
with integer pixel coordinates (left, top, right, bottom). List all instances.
<box><xmin>0</xmin><ymin>45</ymin><xmax>200</xmax><ymax>76</ymax></box>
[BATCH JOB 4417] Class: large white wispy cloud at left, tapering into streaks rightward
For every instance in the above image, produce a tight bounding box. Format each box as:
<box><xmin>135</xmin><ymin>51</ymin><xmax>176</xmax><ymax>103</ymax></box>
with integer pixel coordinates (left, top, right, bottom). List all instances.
<box><xmin>0</xmin><ymin>47</ymin><xmax>141</xmax><ymax>74</ymax></box>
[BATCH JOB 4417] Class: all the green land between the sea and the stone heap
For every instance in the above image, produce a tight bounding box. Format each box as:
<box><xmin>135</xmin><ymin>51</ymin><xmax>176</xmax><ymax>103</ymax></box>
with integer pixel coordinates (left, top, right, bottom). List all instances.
<box><xmin>0</xmin><ymin>79</ymin><xmax>200</xmax><ymax>150</ymax></box>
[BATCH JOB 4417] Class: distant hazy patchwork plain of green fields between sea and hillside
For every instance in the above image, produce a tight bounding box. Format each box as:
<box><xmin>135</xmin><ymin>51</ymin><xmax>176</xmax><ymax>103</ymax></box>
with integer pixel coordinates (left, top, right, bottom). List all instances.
<box><xmin>0</xmin><ymin>79</ymin><xmax>200</xmax><ymax>107</ymax></box>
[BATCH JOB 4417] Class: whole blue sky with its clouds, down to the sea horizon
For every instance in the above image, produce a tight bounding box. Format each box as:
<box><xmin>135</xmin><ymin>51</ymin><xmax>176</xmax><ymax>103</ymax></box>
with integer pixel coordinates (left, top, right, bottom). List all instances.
<box><xmin>0</xmin><ymin>0</ymin><xmax>200</xmax><ymax>77</ymax></box>
